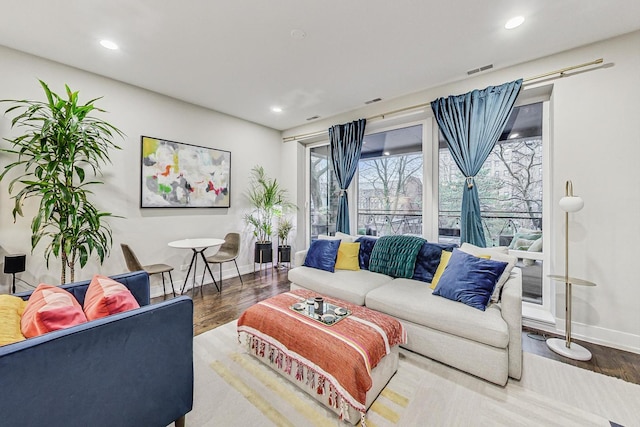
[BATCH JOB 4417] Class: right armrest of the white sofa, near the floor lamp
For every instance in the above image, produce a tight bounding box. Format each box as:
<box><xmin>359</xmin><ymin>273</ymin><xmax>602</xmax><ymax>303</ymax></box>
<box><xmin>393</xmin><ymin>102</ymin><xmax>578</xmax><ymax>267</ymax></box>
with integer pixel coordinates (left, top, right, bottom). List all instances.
<box><xmin>501</xmin><ymin>267</ymin><xmax>522</xmax><ymax>380</ymax></box>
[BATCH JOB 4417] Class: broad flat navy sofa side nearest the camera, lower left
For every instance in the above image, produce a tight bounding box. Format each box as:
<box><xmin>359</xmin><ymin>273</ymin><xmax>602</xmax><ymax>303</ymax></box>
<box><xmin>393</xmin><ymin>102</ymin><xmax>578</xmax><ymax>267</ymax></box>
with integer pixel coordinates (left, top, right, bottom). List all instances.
<box><xmin>0</xmin><ymin>297</ymin><xmax>193</xmax><ymax>427</ymax></box>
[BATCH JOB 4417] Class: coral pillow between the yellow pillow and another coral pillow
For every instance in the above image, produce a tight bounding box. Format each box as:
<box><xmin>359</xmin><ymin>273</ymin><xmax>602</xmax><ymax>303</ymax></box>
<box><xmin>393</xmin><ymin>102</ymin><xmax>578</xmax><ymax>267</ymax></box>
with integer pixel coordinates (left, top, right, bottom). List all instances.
<box><xmin>20</xmin><ymin>283</ymin><xmax>87</xmax><ymax>338</ymax></box>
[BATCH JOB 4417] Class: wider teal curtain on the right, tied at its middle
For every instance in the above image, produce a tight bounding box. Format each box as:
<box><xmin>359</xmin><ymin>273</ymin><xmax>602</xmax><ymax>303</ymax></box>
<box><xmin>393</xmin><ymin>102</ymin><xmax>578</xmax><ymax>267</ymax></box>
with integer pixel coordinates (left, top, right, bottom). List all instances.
<box><xmin>431</xmin><ymin>79</ymin><xmax>522</xmax><ymax>247</ymax></box>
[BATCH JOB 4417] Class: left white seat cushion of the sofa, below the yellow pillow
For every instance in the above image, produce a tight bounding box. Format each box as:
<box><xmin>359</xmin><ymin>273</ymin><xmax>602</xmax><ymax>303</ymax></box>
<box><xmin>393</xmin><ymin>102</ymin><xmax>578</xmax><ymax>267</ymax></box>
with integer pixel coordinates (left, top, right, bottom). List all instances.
<box><xmin>289</xmin><ymin>267</ymin><xmax>392</xmax><ymax>305</ymax></box>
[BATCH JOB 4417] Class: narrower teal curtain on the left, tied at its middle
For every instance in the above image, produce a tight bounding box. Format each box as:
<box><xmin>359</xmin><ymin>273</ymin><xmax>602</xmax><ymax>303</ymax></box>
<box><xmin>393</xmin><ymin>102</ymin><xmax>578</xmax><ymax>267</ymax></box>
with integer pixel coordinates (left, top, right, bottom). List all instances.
<box><xmin>329</xmin><ymin>119</ymin><xmax>367</xmax><ymax>234</ymax></box>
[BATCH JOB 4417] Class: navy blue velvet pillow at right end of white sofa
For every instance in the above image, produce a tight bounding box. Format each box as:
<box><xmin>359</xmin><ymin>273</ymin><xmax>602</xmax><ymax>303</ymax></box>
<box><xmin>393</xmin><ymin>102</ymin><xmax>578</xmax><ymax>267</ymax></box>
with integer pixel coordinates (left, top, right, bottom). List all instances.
<box><xmin>433</xmin><ymin>249</ymin><xmax>507</xmax><ymax>311</ymax></box>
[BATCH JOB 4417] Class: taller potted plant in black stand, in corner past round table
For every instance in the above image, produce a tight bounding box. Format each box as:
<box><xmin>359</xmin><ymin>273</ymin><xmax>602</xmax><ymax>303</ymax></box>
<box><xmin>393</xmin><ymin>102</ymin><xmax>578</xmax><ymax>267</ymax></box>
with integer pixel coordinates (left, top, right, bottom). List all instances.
<box><xmin>244</xmin><ymin>165</ymin><xmax>295</xmax><ymax>263</ymax></box>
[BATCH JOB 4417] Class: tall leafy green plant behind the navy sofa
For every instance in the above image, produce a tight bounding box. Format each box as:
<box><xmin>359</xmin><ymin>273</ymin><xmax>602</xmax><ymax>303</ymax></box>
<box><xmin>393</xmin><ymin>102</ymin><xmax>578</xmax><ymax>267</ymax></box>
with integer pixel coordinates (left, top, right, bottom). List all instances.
<box><xmin>0</xmin><ymin>80</ymin><xmax>124</xmax><ymax>283</ymax></box>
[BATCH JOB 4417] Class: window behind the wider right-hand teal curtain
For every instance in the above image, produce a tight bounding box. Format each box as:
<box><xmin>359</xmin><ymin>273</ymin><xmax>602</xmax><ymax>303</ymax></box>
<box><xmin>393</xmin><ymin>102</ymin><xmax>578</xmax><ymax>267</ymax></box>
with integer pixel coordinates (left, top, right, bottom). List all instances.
<box><xmin>438</xmin><ymin>102</ymin><xmax>543</xmax><ymax>304</ymax></box>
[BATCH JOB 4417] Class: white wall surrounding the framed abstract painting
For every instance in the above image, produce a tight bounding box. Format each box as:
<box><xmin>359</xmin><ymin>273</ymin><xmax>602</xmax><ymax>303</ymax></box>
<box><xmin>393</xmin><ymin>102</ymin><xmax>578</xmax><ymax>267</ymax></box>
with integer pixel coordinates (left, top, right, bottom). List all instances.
<box><xmin>0</xmin><ymin>47</ymin><xmax>283</xmax><ymax>294</ymax></box>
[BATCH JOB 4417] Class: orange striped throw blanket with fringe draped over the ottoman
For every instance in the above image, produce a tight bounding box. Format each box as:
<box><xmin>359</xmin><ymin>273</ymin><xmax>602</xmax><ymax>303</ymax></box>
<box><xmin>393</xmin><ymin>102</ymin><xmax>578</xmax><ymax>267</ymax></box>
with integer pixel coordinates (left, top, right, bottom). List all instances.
<box><xmin>238</xmin><ymin>289</ymin><xmax>406</xmax><ymax>420</ymax></box>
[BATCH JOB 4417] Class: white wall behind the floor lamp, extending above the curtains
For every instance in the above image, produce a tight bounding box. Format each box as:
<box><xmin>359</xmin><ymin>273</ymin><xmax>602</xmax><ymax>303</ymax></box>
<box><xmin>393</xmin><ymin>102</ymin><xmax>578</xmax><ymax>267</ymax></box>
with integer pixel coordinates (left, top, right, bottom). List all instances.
<box><xmin>284</xmin><ymin>32</ymin><xmax>640</xmax><ymax>352</ymax></box>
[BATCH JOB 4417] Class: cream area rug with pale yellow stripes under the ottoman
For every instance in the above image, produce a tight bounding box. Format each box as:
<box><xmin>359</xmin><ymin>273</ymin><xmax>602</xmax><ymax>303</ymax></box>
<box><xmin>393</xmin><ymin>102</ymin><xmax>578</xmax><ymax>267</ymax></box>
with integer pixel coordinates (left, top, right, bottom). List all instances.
<box><xmin>187</xmin><ymin>322</ymin><xmax>640</xmax><ymax>427</ymax></box>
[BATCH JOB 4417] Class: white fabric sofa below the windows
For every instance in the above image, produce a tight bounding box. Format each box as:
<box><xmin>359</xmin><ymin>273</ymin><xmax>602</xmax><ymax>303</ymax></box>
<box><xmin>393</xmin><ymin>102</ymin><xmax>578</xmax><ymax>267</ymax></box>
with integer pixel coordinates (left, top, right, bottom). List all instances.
<box><xmin>289</xmin><ymin>242</ymin><xmax>522</xmax><ymax>385</ymax></box>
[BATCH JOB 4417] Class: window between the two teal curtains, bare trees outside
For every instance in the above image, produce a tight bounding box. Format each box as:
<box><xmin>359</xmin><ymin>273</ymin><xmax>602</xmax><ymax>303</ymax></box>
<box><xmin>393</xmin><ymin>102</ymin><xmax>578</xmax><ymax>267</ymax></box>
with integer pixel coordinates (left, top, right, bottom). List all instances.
<box><xmin>357</xmin><ymin>125</ymin><xmax>423</xmax><ymax>236</ymax></box>
